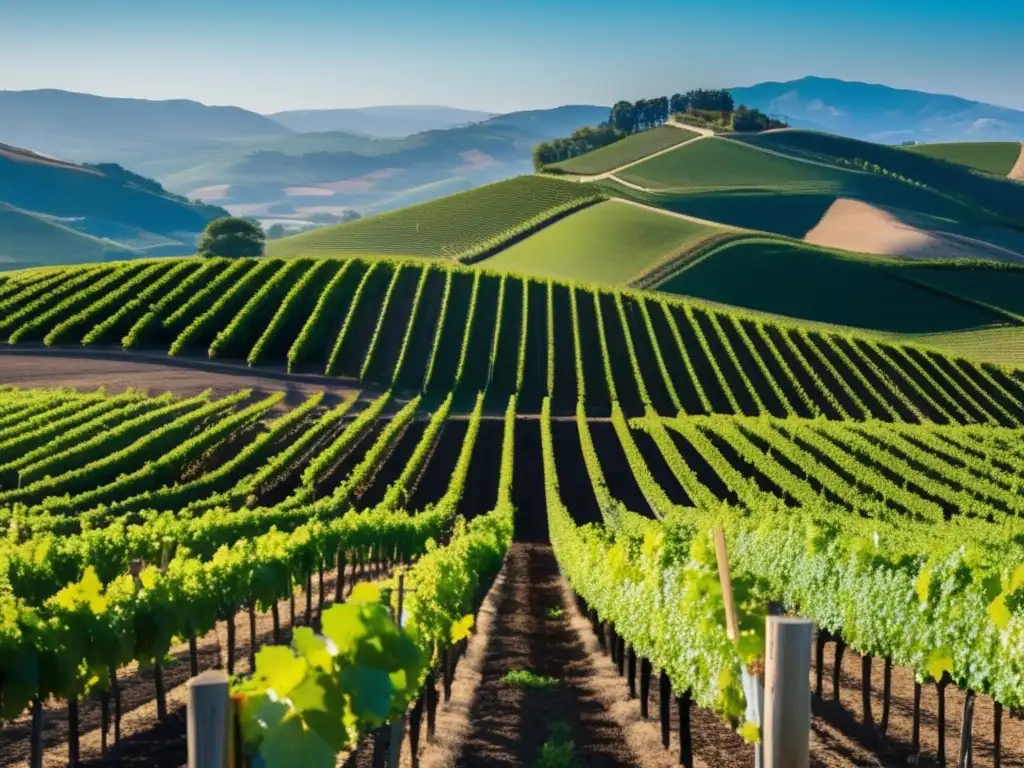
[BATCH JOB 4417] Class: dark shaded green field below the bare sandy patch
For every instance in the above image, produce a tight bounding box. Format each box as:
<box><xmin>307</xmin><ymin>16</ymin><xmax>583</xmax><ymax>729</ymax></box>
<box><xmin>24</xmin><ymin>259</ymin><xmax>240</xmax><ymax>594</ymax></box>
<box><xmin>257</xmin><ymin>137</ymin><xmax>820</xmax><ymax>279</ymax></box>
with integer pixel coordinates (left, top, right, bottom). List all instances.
<box><xmin>658</xmin><ymin>238</ymin><xmax>1004</xmax><ymax>334</ymax></box>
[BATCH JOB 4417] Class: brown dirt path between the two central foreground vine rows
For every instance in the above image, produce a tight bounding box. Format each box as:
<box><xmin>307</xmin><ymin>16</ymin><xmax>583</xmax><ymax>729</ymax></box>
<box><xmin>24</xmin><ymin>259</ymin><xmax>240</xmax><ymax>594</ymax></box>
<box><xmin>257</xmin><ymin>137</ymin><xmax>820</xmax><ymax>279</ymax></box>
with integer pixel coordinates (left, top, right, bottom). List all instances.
<box><xmin>442</xmin><ymin>543</ymin><xmax>644</xmax><ymax>768</ymax></box>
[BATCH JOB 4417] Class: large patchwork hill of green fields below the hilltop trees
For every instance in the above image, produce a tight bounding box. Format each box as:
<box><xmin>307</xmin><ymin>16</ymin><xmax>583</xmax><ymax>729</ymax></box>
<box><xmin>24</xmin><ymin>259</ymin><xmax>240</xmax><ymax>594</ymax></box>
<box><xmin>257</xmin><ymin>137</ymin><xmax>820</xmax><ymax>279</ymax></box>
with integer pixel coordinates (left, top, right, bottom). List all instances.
<box><xmin>260</xmin><ymin>118</ymin><xmax>1024</xmax><ymax>366</ymax></box>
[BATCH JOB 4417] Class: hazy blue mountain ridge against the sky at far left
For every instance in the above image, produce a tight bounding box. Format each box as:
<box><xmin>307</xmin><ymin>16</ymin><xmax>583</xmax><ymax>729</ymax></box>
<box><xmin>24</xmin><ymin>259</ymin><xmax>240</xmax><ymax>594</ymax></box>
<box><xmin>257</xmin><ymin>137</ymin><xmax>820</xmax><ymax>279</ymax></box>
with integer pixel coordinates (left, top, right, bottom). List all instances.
<box><xmin>0</xmin><ymin>90</ymin><xmax>292</xmax><ymax>161</ymax></box>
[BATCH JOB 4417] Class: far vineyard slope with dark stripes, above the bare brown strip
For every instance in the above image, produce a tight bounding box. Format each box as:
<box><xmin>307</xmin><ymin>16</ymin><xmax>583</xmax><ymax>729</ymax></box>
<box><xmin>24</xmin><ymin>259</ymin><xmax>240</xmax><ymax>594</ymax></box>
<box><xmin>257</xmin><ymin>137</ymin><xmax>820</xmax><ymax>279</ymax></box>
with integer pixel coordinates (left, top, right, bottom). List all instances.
<box><xmin>8</xmin><ymin>259</ymin><xmax>1024</xmax><ymax>426</ymax></box>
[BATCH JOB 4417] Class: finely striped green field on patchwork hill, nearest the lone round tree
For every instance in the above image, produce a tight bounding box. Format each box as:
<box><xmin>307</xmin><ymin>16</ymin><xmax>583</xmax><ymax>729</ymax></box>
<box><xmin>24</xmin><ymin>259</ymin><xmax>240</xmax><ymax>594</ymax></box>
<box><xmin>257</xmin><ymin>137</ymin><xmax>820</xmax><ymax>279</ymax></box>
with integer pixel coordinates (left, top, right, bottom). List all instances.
<box><xmin>267</xmin><ymin>176</ymin><xmax>596</xmax><ymax>258</ymax></box>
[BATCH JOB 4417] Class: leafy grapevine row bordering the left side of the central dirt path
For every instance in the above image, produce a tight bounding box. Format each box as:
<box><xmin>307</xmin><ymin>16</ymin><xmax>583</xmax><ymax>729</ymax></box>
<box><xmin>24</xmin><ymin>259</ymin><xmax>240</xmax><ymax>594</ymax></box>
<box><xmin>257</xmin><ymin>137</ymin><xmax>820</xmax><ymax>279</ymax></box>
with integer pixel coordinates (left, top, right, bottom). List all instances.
<box><xmin>233</xmin><ymin>399</ymin><xmax>515</xmax><ymax>768</ymax></box>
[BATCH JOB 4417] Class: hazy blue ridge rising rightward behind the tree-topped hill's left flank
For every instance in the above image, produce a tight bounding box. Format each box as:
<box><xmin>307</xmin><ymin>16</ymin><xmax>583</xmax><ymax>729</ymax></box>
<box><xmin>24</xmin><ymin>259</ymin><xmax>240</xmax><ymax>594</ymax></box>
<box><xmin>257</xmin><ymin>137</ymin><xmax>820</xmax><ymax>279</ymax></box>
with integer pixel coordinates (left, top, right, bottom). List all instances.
<box><xmin>158</xmin><ymin>105</ymin><xmax>608</xmax><ymax>220</ymax></box>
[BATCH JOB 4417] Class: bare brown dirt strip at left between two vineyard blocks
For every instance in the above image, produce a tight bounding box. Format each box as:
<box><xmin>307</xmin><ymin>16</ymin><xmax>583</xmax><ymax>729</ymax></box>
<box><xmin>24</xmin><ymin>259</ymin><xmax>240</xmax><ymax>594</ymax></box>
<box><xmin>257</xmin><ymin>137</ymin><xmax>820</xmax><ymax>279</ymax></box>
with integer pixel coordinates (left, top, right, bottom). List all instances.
<box><xmin>0</xmin><ymin>347</ymin><xmax>359</xmax><ymax>404</ymax></box>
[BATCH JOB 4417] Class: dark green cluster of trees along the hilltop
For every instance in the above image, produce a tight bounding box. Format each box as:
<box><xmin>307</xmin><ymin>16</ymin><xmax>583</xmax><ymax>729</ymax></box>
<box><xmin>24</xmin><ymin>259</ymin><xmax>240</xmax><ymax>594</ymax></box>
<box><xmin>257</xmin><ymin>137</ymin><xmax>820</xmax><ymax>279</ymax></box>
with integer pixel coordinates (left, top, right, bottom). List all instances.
<box><xmin>534</xmin><ymin>88</ymin><xmax>785</xmax><ymax>169</ymax></box>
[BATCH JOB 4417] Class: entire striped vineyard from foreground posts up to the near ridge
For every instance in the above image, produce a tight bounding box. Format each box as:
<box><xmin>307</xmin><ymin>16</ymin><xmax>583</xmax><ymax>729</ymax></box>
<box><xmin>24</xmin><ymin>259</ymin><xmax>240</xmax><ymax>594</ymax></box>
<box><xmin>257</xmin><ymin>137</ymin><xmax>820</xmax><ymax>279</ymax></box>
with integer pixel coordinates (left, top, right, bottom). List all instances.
<box><xmin>0</xmin><ymin>253</ymin><xmax>1024</xmax><ymax>766</ymax></box>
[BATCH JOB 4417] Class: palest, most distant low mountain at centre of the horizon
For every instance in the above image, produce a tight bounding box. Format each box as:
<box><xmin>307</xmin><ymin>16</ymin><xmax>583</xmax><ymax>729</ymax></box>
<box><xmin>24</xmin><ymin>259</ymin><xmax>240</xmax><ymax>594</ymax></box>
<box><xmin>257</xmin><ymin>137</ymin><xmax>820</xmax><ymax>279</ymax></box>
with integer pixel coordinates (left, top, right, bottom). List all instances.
<box><xmin>267</xmin><ymin>104</ymin><xmax>494</xmax><ymax>138</ymax></box>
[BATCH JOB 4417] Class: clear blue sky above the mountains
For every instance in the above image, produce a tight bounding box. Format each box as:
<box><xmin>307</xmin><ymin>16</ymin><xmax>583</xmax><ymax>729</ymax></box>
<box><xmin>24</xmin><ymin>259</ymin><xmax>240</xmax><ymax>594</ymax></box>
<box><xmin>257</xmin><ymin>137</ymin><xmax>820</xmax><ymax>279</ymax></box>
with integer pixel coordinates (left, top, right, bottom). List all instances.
<box><xmin>0</xmin><ymin>0</ymin><xmax>1024</xmax><ymax>112</ymax></box>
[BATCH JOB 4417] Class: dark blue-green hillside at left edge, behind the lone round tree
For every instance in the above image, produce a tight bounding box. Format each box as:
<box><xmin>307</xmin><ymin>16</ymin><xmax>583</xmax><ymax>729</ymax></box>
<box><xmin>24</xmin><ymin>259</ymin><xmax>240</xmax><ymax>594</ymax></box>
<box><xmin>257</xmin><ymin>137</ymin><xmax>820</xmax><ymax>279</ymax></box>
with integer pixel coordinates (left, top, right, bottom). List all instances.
<box><xmin>0</xmin><ymin>144</ymin><xmax>224</xmax><ymax>263</ymax></box>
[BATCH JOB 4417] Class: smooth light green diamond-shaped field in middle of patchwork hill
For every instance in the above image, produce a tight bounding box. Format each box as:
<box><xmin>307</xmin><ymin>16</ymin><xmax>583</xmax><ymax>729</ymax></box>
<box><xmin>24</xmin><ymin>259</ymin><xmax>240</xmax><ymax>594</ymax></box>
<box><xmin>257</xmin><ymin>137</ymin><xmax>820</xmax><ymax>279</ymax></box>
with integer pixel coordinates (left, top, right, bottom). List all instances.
<box><xmin>483</xmin><ymin>201</ymin><xmax>719</xmax><ymax>285</ymax></box>
